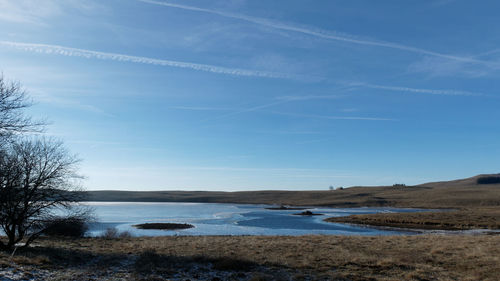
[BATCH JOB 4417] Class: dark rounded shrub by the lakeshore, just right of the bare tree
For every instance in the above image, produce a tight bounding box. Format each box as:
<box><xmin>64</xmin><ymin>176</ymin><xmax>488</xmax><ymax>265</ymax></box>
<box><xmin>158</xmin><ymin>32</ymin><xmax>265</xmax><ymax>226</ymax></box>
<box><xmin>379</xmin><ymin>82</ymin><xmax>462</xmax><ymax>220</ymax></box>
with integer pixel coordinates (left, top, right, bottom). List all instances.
<box><xmin>43</xmin><ymin>217</ymin><xmax>88</xmax><ymax>237</ymax></box>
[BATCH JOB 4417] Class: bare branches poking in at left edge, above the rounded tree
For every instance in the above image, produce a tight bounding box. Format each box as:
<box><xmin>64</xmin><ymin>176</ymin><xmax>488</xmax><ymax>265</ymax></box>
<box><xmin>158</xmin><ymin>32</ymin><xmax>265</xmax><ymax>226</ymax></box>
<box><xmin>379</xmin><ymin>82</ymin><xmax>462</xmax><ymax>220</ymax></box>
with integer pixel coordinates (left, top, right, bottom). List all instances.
<box><xmin>0</xmin><ymin>73</ymin><xmax>44</xmax><ymax>141</ymax></box>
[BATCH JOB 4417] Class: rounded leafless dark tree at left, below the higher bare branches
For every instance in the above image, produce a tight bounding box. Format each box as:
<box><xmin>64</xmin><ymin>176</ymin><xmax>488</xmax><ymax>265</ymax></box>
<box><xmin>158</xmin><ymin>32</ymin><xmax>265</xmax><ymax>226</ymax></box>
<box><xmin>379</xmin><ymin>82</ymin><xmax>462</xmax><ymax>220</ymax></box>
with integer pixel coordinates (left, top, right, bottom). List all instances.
<box><xmin>0</xmin><ymin>139</ymin><xmax>82</xmax><ymax>250</ymax></box>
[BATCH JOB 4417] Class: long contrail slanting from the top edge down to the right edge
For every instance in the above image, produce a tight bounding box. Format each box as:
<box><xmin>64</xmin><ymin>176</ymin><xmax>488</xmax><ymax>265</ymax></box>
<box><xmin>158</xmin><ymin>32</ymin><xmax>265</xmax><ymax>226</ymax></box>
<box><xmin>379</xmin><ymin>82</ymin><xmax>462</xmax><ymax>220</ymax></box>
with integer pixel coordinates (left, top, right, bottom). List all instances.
<box><xmin>137</xmin><ymin>0</ymin><xmax>500</xmax><ymax>68</ymax></box>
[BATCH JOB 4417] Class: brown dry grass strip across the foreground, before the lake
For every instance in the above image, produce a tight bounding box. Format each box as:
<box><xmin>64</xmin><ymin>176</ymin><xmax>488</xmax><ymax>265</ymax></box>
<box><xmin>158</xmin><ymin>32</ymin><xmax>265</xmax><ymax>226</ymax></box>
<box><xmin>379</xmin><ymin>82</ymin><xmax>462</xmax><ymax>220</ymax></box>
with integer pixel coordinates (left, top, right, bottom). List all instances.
<box><xmin>0</xmin><ymin>235</ymin><xmax>500</xmax><ymax>280</ymax></box>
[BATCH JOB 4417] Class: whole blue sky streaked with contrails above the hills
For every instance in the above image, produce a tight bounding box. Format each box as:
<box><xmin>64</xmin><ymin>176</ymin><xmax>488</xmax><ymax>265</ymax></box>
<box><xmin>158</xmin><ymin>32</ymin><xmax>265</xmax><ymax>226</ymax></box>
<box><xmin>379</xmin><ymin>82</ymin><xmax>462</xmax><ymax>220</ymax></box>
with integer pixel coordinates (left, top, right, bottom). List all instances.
<box><xmin>0</xmin><ymin>0</ymin><xmax>500</xmax><ymax>190</ymax></box>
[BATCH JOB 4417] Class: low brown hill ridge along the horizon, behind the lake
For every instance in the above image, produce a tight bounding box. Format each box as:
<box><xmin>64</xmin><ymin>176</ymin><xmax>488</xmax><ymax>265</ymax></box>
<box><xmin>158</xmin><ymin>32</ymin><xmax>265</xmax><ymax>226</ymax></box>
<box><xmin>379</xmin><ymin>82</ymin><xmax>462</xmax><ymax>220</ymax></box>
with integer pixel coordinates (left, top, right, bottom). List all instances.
<box><xmin>86</xmin><ymin>174</ymin><xmax>500</xmax><ymax>208</ymax></box>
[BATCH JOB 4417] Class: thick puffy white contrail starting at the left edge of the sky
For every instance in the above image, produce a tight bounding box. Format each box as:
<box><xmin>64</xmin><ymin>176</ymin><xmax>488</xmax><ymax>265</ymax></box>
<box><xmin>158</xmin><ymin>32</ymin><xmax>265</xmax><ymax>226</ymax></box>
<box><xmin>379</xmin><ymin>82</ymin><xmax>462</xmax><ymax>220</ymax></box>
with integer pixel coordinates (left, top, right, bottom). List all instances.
<box><xmin>0</xmin><ymin>41</ymin><xmax>296</xmax><ymax>79</ymax></box>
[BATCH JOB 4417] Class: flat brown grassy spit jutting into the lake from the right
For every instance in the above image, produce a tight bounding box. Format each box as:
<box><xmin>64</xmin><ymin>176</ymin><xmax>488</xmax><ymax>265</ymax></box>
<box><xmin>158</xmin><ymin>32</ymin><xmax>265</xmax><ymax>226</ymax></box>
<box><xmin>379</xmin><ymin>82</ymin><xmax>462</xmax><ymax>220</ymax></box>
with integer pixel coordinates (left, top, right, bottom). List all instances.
<box><xmin>326</xmin><ymin>207</ymin><xmax>500</xmax><ymax>230</ymax></box>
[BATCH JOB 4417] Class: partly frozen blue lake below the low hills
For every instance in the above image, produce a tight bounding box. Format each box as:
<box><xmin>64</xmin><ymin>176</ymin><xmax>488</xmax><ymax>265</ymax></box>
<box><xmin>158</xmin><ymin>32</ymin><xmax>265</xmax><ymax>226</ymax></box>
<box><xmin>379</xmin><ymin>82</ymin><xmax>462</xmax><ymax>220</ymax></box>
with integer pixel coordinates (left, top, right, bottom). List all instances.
<box><xmin>87</xmin><ymin>202</ymin><xmax>419</xmax><ymax>236</ymax></box>
